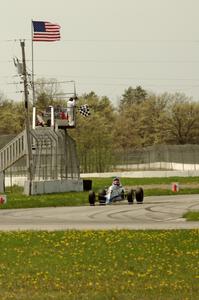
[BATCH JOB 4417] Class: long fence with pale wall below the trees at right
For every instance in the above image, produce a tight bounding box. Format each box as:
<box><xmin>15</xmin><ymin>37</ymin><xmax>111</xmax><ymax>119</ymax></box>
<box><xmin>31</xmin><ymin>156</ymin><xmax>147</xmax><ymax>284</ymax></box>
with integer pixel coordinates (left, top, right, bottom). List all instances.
<box><xmin>114</xmin><ymin>144</ymin><xmax>199</xmax><ymax>171</ymax></box>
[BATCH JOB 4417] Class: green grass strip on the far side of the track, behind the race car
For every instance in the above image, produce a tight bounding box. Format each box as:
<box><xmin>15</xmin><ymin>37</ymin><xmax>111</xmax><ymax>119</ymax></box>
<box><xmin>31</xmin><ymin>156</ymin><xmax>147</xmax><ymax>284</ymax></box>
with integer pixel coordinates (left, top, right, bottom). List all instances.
<box><xmin>0</xmin><ymin>177</ymin><xmax>199</xmax><ymax>209</ymax></box>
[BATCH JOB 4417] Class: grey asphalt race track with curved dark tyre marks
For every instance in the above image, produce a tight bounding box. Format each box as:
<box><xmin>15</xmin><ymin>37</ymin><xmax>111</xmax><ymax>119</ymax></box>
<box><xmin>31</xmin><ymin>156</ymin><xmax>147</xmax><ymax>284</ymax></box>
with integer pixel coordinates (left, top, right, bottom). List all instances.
<box><xmin>0</xmin><ymin>195</ymin><xmax>199</xmax><ymax>231</ymax></box>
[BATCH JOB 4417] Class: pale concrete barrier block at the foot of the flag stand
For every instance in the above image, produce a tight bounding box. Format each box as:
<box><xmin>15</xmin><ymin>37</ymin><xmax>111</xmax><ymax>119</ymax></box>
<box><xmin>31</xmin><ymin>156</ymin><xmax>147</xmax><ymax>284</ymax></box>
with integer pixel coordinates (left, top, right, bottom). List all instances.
<box><xmin>24</xmin><ymin>179</ymin><xmax>83</xmax><ymax>195</ymax></box>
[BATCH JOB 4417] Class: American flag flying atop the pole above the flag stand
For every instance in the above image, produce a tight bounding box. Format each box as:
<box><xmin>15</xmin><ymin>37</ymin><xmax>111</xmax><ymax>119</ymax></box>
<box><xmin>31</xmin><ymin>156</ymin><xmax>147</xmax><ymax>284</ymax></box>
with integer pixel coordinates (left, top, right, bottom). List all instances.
<box><xmin>32</xmin><ymin>21</ymin><xmax>60</xmax><ymax>42</ymax></box>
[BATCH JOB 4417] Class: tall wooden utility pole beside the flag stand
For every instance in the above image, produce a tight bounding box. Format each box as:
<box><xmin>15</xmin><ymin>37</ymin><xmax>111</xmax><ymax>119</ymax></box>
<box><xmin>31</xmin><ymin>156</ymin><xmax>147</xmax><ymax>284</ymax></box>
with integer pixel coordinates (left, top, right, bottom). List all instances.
<box><xmin>20</xmin><ymin>40</ymin><xmax>33</xmax><ymax>195</ymax></box>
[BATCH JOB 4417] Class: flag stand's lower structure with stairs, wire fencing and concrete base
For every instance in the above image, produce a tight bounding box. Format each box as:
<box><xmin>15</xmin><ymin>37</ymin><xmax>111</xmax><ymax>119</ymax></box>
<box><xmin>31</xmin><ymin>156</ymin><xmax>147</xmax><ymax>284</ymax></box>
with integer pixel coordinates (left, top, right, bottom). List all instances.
<box><xmin>0</xmin><ymin>127</ymin><xmax>83</xmax><ymax>195</ymax></box>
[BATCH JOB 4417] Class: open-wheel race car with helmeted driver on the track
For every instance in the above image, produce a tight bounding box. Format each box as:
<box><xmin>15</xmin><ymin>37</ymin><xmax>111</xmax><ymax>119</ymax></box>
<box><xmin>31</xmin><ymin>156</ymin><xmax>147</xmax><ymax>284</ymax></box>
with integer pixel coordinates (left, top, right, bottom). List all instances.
<box><xmin>88</xmin><ymin>185</ymin><xmax>144</xmax><ymax>206</ymax></box>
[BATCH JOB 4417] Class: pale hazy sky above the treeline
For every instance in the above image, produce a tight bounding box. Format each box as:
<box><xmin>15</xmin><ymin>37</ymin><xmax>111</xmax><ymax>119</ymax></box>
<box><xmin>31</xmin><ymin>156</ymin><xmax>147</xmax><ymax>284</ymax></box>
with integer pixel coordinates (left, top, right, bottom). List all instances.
<box><xmin>0</xmin><ymin>0</ymin><xmax>199</xmax><ymax>103</ymax></box>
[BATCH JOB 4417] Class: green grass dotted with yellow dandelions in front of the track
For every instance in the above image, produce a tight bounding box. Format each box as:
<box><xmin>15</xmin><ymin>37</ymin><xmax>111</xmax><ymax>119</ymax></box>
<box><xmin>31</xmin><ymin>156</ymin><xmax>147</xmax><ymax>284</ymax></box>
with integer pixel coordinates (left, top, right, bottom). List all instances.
<box><xmin>0</xmin><ymin>230</ymin><xmax>199</xmax><ymax>300</ymax></box>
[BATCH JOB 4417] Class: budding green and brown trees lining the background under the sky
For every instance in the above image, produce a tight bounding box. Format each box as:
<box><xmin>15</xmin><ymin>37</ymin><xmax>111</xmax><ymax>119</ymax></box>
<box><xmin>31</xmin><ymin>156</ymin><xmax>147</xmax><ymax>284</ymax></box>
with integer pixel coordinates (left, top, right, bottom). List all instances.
<box><xmin>0</xmin><ymin>80</ymin><xmax>199</xmax><ymax>172</ymax></box>
